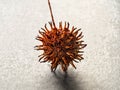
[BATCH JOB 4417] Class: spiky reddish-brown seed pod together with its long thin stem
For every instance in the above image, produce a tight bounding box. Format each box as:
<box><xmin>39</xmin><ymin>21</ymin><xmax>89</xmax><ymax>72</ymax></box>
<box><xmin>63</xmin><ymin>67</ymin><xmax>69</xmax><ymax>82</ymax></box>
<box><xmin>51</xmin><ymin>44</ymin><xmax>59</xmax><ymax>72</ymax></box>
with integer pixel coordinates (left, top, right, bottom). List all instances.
<box><xmin>35</xmin><ymin>0</ymin><xmax>87</xmax><ymax>72</ymax></box>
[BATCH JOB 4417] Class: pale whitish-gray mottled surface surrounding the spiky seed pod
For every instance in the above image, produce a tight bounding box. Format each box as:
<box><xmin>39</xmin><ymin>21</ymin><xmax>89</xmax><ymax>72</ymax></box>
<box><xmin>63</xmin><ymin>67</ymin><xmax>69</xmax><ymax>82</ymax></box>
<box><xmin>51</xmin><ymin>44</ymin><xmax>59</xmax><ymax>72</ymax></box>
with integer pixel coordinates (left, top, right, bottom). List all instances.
<box><xmin>0</xmin><ymin>0</ymin><xmax>120</xmax><ymax>90</ymax></box>
